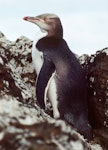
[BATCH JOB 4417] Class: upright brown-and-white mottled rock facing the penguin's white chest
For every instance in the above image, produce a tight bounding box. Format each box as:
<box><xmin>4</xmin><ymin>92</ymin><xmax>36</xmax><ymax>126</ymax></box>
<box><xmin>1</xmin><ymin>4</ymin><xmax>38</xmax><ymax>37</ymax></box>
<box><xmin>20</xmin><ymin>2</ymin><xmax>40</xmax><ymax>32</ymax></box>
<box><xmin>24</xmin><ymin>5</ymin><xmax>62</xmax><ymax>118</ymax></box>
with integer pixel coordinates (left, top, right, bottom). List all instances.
<box><xmin>0</xmin><ymin>33</ymin><xmax>35</xmax><ymax>103</ymax></box>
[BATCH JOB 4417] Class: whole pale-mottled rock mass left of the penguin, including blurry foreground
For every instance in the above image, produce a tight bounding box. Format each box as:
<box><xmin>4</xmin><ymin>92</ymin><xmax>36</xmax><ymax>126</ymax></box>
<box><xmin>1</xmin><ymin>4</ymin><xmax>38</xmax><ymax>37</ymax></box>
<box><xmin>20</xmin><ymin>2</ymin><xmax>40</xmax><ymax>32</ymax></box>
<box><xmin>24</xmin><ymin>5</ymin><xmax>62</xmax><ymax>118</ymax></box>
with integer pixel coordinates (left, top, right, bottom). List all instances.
<box><xmin>0</xmin><ymin>33</ymin><xmax>102</xmax><ymax>150</ymax></box>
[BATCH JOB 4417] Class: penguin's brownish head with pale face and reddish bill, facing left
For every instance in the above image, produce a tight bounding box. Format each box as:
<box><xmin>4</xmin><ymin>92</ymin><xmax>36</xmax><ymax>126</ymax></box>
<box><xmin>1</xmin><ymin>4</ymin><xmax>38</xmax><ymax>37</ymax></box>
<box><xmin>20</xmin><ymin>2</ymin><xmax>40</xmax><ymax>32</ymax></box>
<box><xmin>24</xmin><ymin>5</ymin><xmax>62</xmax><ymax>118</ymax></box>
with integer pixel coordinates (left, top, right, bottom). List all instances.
<box><xmin>23</xmin><ymin>13</ymin><xmax>63</xmax><ymax>38</ymax></box>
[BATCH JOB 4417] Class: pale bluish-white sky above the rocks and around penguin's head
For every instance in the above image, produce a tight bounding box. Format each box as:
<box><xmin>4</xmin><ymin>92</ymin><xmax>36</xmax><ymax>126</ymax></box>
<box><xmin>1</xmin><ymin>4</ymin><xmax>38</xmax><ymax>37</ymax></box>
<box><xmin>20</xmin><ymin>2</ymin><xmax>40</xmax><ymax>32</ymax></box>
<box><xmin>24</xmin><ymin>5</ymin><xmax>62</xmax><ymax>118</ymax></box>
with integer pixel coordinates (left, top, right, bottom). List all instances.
<box><xmin>0</xmin><ymin>0</ymin><xmax>108</xmax><ymax>55</ymax></box>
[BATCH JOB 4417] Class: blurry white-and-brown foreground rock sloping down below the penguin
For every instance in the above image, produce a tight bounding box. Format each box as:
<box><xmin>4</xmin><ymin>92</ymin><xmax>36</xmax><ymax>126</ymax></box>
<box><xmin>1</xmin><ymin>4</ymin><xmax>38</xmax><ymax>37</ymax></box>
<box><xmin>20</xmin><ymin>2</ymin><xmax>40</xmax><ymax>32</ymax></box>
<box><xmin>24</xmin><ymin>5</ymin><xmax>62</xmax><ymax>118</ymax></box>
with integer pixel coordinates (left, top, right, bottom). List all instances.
<box><xmin>0</xmin><ymin>96</ymin><xmax>87</xmax><ymax>150</ymax></box>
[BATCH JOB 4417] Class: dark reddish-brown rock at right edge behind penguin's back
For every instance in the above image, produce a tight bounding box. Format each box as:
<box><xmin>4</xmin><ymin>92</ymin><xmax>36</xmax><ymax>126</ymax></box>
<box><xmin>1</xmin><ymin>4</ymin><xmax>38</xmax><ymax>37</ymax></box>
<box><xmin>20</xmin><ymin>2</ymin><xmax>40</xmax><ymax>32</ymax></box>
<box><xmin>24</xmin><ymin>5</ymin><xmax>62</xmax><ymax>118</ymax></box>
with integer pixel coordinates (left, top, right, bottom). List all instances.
<box><xmin>80</xmin><ymin>48</ymin><xmax>108</xmax><ymax>149</ymax></box>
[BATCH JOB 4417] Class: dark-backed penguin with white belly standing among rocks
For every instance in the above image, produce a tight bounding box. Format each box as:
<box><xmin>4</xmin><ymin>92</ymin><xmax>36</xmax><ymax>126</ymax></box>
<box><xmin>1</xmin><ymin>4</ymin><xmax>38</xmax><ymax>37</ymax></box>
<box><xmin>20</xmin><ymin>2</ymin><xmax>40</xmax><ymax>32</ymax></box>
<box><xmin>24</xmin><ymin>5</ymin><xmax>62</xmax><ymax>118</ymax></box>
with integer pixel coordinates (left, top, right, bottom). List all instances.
<box><xmin>23</xmin><ymin>13</ymin><xmax>92</xmax><ymax>139</ymax></box>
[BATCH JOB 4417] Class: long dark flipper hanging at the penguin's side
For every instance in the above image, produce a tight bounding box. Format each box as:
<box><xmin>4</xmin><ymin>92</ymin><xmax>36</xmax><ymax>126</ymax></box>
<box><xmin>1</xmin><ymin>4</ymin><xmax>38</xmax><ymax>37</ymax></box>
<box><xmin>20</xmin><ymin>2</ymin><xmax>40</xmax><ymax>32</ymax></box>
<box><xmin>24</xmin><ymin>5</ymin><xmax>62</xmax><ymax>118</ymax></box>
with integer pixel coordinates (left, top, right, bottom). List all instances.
<box><xmin>36</xmin><ymin>57</ymin><xmax>55</xmax><ymax>109</ymax></box>
